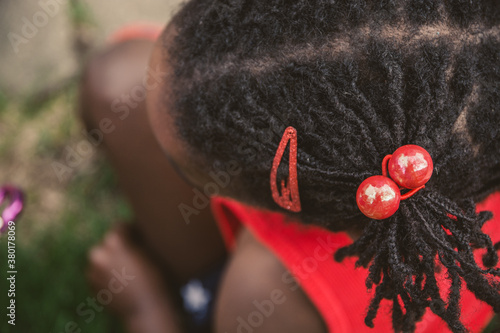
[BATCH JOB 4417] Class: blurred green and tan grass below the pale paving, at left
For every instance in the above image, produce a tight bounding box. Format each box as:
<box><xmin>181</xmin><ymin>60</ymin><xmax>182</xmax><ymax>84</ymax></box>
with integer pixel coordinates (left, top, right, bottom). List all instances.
<box><xmin>0</xmin><ymin>76</ymin><xmax>131</xmax><ymax>333</ymax></box>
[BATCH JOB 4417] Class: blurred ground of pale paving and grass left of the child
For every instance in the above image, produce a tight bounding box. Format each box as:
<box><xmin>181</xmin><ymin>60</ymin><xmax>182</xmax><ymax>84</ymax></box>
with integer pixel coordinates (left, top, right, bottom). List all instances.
<box><xmin>0</xmin><ymin>0</ymin><xmax>180</xmax><ymax>333</ymax></box>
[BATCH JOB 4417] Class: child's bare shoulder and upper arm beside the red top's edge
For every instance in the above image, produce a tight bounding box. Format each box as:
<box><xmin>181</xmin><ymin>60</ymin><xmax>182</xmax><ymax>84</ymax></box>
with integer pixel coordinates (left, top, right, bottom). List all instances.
<box><xmin>215</xmin><ymin>229</ymin><xmax>327</xmax><ymax>333</ymax></box>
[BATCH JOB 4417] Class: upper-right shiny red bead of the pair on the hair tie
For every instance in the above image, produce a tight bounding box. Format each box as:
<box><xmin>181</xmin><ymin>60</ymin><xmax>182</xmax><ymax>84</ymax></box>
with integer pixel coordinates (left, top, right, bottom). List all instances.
<box><xmin>388</xmin><ymin>145</ymin><xmax>433</xmax><ymax>189</ymax></box>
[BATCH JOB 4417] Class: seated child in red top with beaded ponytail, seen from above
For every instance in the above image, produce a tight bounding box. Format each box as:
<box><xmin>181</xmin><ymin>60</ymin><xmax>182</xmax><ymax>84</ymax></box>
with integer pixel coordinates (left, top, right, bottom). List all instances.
<box><xmin>82</xmin><ymin>0</ymin><xmax>500</xmax><ymax>333</ymax></box>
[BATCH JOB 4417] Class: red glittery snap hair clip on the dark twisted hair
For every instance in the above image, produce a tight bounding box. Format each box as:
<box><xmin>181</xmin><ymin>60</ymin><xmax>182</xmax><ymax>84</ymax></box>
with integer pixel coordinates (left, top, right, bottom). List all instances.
<box><xmin>270</xmin><ymin>126</ymin><xmax>302</xmax><ymax>212</ymax></box>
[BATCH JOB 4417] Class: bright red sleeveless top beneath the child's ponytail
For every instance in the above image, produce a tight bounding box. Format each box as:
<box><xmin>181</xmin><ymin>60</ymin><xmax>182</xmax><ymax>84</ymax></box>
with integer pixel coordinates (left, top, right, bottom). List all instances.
<box><xmin>212</xmin><ymin>192</ymin><xmax>500</xmax><ymax>333</ymax></box>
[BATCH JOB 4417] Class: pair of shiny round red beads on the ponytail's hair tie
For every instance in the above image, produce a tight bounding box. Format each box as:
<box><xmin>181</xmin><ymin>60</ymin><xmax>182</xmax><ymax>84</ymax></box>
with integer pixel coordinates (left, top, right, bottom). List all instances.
<box><xmin>356</xmin><ymin>145</ymin><xmax>433</xmax><ymax>220</ymax></box>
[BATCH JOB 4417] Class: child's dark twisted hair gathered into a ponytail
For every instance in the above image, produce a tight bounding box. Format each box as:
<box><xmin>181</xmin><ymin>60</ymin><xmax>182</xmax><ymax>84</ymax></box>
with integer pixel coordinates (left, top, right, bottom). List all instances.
<box><xmin>165</xmin><ymin>0</ymin><xmax>500</xmax><ymax>332</ymax></box>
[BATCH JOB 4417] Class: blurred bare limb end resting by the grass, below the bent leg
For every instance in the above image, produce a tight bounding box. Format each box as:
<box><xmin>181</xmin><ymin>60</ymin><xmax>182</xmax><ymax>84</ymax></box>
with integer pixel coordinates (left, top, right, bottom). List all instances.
<box><xmin>87</xmin><ymin>225</ymin><xmax>187</xmax><ymax>333</ymax></box>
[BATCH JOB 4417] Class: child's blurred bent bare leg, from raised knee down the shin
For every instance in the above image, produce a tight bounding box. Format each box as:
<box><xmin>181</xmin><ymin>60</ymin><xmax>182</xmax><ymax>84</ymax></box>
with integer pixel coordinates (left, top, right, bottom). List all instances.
<box><xmin>82</xmin><ymin>37</ymin><xmax>226</xmax><ymax>284</ymax></box>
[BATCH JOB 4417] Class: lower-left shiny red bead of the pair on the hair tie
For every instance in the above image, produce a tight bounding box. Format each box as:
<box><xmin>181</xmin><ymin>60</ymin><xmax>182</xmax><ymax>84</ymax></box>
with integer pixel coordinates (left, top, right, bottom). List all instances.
<box><xmin>356</xmin><ymin>176</ymin><xmax>401</xmax><ymax>220</ymax></box>
